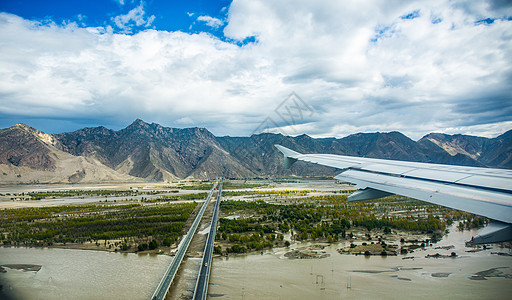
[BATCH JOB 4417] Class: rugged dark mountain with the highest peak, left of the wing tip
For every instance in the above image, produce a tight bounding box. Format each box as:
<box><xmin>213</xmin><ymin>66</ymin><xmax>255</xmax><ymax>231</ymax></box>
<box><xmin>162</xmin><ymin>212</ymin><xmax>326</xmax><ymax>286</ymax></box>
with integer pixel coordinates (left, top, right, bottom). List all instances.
<box><xmin>55</xmin><ymin>119</ymin><xmax>254</xmax><ymax>181</ymax></box>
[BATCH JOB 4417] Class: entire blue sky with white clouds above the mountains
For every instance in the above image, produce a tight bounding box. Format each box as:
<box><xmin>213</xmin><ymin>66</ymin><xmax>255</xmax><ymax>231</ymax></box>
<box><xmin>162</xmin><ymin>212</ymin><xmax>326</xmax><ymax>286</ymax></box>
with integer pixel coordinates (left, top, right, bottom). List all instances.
<box><xmin>0</xmin><ymin>0</ymin><xmax>512</xmax><ymax>139</ymax></box>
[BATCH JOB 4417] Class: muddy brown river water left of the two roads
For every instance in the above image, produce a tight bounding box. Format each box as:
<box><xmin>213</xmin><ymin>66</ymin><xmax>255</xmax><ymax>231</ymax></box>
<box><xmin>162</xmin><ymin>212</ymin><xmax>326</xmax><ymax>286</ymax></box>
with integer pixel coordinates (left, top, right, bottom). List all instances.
<box><xmin>0</xmin><ymin>248</ymin><xmax>172</xmax><ymax>299</ymax></box>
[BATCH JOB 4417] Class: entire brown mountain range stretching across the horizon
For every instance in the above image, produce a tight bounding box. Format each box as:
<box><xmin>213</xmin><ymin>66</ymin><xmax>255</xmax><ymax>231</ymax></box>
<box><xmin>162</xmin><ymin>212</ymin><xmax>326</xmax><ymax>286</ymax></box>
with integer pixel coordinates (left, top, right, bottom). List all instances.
<box><xmin>0</xmin><ymin>119</ymin><xmax>512</xmax><ymax>184</ymax></box>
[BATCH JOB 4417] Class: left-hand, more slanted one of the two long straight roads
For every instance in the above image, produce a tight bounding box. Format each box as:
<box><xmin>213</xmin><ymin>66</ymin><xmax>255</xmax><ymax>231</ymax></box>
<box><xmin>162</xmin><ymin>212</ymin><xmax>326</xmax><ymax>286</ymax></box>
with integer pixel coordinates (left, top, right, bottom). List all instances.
<box><xmin>151</xmin><ymin>180</ymin><xmax>220</xmax><ymax>300</ymax></box>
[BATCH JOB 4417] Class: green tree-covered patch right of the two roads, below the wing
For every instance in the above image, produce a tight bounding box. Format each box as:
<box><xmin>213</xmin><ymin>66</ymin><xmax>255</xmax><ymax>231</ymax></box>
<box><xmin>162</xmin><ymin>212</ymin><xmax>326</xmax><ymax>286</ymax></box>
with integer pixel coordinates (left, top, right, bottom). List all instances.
<box><xmin>217</xmin><ymin>195</ymin><xmax>485</xmax><ymax>255</ymax></box>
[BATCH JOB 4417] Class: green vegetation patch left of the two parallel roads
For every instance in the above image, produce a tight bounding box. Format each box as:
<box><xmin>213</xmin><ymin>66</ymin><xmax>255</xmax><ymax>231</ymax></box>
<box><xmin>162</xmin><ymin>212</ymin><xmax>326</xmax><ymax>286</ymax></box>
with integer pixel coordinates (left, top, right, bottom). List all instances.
<box><xmin>0</xmin><ymin>202</ymin><xmax>197</xmax><ymax>251</ymax></box>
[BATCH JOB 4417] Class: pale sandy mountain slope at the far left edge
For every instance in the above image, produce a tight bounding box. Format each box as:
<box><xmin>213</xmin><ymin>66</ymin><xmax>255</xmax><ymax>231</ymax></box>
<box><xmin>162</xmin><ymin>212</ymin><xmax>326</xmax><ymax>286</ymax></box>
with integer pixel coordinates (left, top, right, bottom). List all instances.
<box><xmin>0</xmin><ymin>124</ymin><xmax>138</xmax><ymax>184</ymax></box>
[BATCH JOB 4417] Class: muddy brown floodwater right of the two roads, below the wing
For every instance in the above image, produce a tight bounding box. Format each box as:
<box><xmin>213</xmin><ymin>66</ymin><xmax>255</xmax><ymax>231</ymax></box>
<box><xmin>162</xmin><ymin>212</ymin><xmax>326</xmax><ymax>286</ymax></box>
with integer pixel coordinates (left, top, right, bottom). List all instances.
<box><xmin>209</xmin><ymin>227</ymin><xmax>512</xmax><ymax>299</ymax></box>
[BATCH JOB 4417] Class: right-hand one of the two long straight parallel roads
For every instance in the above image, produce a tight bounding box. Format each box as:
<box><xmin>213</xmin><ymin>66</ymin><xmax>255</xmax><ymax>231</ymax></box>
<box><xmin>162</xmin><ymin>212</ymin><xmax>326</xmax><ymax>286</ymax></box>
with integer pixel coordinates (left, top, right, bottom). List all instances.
<box><xmin>194</xmin><ymin>179</ymin><xmax>222</xmax><ymax>300</ymax></box>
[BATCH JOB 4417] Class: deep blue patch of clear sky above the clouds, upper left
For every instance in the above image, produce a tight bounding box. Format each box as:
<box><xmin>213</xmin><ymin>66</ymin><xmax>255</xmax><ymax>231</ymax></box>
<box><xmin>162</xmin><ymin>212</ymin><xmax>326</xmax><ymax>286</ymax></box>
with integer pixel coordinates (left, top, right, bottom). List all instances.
<box><xmin>0</xmin><ymin>0</ymin><xmax>231</xmax><ymax>37</ymax></box>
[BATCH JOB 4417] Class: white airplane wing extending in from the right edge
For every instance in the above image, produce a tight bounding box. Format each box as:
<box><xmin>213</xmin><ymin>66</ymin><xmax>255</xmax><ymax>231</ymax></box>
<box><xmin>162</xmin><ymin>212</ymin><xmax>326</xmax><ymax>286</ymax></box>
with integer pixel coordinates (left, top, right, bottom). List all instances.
<box><xmin>275</xmin><ymin>145</ymin><xmax>512</xmax><ymax>244</ymax></box>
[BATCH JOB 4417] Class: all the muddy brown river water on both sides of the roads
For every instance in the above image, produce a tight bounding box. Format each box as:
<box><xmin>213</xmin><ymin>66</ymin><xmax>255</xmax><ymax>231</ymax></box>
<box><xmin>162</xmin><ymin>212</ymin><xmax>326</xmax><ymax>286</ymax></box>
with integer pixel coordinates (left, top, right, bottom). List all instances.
<box><xmin>0</xmin><ymin>224</ymin><xmax>512</xmax><ymax>299</ymax></box>
